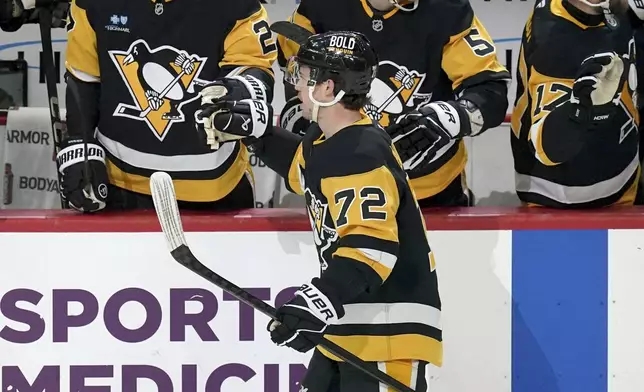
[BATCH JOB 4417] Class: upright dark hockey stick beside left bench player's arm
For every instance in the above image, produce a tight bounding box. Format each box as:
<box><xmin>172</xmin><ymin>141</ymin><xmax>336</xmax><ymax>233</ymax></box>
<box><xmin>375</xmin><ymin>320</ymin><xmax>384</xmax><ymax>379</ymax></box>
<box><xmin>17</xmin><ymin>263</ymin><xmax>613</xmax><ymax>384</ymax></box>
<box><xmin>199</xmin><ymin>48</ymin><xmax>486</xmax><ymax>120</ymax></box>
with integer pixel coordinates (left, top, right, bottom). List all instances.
<box><xmin>37</xmin><ymin>1</ymin><xmax>67</xmax><ymax>209</ymax></box>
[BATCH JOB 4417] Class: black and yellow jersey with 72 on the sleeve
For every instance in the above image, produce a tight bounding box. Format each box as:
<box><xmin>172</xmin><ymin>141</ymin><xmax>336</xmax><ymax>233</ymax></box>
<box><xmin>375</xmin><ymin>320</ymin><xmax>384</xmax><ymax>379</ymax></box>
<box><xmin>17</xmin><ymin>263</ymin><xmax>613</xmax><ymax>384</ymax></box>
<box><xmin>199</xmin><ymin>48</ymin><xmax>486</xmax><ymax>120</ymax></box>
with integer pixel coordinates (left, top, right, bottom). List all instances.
<box><xmin>287</xmin><ymin>117</ymin><xmax>442</xmax><ymax>366</ymax></box>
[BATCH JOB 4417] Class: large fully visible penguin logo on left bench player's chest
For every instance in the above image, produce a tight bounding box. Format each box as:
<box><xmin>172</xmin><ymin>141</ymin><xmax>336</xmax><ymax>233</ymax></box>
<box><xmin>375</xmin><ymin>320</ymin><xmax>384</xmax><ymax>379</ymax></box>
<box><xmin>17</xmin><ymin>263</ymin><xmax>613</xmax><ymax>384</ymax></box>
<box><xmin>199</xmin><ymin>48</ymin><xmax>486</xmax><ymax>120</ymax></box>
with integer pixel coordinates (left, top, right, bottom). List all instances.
<box><xmin>109</xmin><ymin>39</ymin><xmax>209</xmax><ymax>141</ymax></box>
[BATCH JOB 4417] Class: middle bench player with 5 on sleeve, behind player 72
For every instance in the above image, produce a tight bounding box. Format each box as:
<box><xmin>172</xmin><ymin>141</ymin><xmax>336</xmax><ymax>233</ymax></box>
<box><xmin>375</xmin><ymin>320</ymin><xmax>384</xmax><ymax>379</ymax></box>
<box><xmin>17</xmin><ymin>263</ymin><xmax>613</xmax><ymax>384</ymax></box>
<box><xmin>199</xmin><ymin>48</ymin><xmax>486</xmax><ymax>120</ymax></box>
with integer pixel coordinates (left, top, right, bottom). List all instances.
<box><xmin>278</xmin><ymin>0</ymin><xmax>510</xmax><ymax>207</ymax></box>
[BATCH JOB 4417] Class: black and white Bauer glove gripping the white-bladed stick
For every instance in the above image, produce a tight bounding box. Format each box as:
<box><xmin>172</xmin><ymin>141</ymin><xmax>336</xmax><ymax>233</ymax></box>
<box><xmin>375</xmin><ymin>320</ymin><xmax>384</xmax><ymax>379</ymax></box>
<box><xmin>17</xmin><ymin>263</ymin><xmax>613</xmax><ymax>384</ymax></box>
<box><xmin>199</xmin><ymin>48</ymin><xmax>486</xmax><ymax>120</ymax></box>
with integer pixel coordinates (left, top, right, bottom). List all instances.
<box><xmin>267</xmin><ymin>278</ymin><xmax>344</xmax><ymax>353</ymax></box>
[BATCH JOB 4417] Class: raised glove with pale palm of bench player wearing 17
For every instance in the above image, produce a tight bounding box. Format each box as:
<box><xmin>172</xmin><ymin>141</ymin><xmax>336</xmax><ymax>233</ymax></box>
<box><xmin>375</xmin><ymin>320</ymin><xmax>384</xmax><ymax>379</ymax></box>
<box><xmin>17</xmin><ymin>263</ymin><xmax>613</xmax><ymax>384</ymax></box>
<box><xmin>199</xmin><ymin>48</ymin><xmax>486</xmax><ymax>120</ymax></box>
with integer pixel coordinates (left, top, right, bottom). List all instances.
<box><xmin>570</xmin><ymin>52</ymin><xmax>628</xmax><ymax>124</ymax></box>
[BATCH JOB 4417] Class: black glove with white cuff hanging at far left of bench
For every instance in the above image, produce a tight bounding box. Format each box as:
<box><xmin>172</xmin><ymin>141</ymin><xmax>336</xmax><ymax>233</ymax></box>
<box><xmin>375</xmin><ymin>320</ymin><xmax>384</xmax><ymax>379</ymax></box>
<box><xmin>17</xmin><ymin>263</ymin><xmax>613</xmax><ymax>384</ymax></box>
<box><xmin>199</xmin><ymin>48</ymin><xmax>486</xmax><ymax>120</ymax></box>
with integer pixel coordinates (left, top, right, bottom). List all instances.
<box><xmin>56</xmin><ymin>139</ymin><xmax>108</xmax><ymax>212</ymax></box>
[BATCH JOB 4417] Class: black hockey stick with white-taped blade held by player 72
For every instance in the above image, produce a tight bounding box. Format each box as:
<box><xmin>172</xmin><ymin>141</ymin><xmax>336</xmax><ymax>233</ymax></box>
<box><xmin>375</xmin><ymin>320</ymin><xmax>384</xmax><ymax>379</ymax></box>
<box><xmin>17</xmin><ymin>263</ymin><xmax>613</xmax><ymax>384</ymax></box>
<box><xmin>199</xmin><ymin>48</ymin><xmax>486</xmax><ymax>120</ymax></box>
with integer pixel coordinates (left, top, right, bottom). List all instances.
<box><xmin>150</xmin><ymin>172</ymin><xmax>414</xmax><ymax>392</ymax></box>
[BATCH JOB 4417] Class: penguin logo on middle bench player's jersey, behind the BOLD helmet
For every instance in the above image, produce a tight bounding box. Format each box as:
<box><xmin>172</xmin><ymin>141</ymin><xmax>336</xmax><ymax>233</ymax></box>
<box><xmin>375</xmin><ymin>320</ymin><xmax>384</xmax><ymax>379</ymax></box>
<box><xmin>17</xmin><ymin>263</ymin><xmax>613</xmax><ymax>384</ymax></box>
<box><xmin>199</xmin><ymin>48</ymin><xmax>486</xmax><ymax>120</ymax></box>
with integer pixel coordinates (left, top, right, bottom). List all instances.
<box><xmin>363</xmin><ymin>60</ymin><xmax>432</xmax><ymax>127</ymax></box>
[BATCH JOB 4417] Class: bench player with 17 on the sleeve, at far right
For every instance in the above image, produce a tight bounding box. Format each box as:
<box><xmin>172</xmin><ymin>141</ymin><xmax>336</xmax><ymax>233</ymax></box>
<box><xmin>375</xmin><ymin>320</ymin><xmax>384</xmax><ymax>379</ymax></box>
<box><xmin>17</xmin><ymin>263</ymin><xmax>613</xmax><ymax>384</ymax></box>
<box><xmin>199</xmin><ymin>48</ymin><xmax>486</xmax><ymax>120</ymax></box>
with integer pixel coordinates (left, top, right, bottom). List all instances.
<box><xmin>511</xmin><ymin>0</ymin><xmax>641</xmax><ymax>208</ymax></box>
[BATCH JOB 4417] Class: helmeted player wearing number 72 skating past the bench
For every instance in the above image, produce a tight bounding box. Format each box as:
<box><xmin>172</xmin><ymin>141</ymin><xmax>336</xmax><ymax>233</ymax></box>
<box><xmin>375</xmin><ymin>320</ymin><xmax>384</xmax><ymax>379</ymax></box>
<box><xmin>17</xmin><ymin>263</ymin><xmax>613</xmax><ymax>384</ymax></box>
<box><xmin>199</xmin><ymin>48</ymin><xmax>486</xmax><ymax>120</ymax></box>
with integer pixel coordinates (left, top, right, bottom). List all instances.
<box><xmin>194</xmin><ymin>32</ymin><xmax>442</xmax><ymax>392</ymax></box>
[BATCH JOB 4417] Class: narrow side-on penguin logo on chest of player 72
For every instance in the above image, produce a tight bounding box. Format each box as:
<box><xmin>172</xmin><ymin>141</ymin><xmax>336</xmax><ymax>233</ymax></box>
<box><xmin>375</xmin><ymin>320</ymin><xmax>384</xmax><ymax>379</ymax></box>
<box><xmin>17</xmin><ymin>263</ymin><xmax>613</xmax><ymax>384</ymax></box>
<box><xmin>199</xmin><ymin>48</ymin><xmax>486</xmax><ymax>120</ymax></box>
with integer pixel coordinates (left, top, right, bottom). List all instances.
<box><xmin>304</xmin><ymin>188</ymin><xmax>338</xmax><ymax>271</ymax></box>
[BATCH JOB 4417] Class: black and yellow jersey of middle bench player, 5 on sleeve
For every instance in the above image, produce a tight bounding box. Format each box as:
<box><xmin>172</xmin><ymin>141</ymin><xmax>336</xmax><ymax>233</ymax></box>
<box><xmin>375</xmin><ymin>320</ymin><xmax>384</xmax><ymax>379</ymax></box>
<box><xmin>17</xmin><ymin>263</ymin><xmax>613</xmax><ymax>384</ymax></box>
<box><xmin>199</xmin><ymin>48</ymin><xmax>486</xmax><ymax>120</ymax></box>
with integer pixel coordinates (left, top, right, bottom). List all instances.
<box><xmin>278</xmin><ymin>0</ymin><xmax>510</xmax><ymax>199</ymax></box>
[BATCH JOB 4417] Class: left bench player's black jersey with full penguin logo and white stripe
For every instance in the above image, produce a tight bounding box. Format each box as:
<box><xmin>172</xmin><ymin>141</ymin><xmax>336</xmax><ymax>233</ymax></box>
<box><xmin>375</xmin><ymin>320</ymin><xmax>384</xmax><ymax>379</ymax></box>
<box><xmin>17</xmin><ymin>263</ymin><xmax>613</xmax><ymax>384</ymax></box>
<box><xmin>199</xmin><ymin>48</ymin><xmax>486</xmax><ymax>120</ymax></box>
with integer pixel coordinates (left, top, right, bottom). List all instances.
<box><xmin>66</xmin><ymin>0</ymin><xmax>277</xmax><ymax>201</ymax></box>
